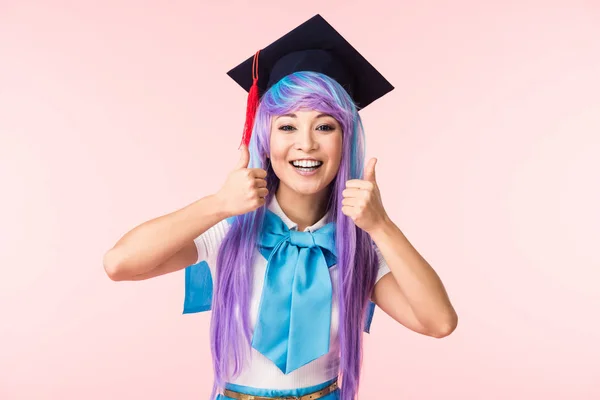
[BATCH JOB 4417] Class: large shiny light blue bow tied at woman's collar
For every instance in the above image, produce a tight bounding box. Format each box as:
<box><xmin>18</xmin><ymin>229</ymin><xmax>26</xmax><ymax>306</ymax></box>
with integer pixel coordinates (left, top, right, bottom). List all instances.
<box><xmin>252</xmin><ymin>210</ymin><xmax>336</xmax><ymax>374</ymax></box>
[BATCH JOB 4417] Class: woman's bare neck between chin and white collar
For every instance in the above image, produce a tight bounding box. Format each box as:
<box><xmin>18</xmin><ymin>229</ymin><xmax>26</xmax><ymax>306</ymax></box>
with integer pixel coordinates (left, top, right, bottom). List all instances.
<box><xmin>275</xmin><ymin>185</ymin><xmax>329</xmax><ymax>232</ymax></box>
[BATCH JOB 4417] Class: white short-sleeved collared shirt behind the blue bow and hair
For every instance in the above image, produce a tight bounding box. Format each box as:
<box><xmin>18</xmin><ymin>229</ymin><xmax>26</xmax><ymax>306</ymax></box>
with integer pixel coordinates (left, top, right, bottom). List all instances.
<box><xmin>194</xmin><ymin>196</ymin><xmax>390</xmax><ymax>389</ymax></box>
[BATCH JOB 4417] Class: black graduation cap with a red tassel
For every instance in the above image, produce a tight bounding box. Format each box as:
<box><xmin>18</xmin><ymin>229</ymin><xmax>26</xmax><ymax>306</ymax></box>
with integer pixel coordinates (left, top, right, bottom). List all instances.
<box><xmin>227</xmin><ymin>14</ymin><xmax>394</xmax><ymax>145</ymax></box>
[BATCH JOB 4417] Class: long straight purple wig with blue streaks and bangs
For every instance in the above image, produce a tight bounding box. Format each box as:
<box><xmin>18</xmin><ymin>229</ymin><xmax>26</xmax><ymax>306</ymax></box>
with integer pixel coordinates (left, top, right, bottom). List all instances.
<box><xmin>210</xmin><ymin>72</ymin><xmax>377</xmax><ymax>400</ymax></box>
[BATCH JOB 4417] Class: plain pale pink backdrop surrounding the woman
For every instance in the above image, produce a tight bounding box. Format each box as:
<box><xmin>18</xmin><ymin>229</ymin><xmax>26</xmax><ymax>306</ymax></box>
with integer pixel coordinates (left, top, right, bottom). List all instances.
<box><xmin>0</xmin><ymin>0</ymin><xmax>600</xmax><ymax>400</ymax></box>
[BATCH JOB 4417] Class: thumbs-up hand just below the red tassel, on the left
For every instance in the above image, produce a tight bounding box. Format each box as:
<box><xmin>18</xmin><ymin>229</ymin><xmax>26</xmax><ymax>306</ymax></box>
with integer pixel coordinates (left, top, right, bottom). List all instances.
<box><xmin>216</xmin><ymin>145</ymin><xmax>268</xmax><ymax>216</ymax></box>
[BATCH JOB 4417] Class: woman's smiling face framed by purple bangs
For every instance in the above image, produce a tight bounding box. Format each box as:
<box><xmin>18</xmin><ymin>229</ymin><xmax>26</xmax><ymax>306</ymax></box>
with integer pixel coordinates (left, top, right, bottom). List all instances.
<box><xmin>270</xmin><ymin>110</ymin><xmax>342</xmax><ymax>195</ymax></box>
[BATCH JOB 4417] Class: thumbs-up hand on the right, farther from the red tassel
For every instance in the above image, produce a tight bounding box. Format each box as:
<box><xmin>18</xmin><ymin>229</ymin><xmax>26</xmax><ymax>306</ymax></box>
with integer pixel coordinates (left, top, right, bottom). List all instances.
<box><xmin>342</xmin><ymin>158</ymin><xmax>388</xmax><ymax>234</ymax></box>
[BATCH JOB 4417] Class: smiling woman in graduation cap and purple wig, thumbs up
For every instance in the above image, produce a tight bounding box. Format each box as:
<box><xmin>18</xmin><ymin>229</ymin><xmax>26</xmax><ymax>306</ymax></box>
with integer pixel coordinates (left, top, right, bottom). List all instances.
<box><xmin>104</xmin><ymin>16</ymin><xmax>457</xmax><ymax>400</ymax></box>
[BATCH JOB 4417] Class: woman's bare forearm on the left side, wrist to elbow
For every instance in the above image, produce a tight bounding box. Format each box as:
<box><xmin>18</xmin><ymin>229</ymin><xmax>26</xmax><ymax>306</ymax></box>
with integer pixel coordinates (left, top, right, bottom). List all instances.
<box><xmin>104</xmin><ymin>195</ymin><xmax>227</xmax><ymax>276</ymax></box>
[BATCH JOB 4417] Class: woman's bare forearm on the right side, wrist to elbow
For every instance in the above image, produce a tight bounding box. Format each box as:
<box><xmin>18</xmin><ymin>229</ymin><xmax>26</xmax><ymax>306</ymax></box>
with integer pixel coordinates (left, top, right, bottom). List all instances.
<box><xmin>371</xmin><ymin>219</ymin><xmax>457</xmax><ymax>331</ymax></box>
